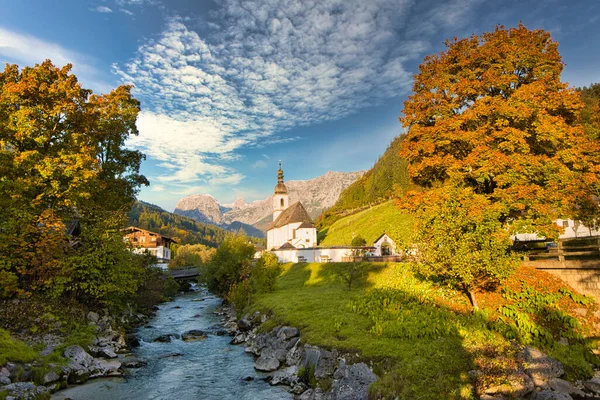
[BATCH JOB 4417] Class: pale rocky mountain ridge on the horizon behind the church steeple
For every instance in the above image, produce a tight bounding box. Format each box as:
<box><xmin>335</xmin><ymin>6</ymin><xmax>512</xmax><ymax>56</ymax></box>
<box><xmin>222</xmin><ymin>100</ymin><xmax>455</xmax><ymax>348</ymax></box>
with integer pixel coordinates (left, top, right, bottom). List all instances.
<box><xmin>174</xmin><ymin>171</ymin><xmax>364</xmax><ymax>233</ymax></box>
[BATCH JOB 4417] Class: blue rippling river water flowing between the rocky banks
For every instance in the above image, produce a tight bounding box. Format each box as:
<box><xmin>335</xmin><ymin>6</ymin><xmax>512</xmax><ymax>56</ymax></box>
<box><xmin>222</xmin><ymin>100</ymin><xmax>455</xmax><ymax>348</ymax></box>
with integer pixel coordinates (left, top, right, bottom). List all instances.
<box><xmin>52</xmin><ymin>289</ymin><xmax>292</xmax><ymax>400</ymax></box>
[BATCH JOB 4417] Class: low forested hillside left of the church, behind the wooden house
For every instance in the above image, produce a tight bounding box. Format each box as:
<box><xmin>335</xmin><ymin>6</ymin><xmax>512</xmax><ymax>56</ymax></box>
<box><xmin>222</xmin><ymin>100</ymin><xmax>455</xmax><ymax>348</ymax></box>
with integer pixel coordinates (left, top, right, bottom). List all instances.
<box><xmin>127</xmin><ymin>201</ymin><xmax>229</xmax><ymax>247</ymax></box>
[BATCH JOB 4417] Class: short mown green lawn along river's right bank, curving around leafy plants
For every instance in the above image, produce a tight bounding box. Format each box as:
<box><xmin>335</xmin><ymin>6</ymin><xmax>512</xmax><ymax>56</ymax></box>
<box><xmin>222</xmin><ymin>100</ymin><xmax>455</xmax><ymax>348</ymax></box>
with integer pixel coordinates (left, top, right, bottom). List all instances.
<box><xmin>256</xmin><ymin>263</ymin><xmax>472</xmax><ymax>399</ymax></box>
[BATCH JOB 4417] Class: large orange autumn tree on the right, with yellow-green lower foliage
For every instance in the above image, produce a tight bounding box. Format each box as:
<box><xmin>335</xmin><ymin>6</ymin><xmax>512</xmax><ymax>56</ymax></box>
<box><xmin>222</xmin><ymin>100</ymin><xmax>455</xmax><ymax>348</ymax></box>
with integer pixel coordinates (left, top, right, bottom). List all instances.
<box><xmin>400</xmin><ymin>25</ymin><xmax>599</xmax><ymax>304</ymax></box>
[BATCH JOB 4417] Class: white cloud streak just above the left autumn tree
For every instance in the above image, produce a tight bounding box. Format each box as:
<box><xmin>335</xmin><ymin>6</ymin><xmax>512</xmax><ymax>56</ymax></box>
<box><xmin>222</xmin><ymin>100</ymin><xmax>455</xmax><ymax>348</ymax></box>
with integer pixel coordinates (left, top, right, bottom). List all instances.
<box><xmin>0</xmin><ymin>27</ymin><xmax>112</xmax><ymax>92</ymax></box>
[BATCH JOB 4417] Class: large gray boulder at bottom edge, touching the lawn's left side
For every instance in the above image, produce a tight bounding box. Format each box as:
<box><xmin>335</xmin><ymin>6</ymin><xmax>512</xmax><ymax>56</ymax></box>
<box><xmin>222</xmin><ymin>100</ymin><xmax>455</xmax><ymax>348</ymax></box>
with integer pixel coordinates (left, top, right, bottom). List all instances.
<box><xmin>331</xmin><ymin>362</ymin><xmax>377</xmax><ymax>400</ymax></box>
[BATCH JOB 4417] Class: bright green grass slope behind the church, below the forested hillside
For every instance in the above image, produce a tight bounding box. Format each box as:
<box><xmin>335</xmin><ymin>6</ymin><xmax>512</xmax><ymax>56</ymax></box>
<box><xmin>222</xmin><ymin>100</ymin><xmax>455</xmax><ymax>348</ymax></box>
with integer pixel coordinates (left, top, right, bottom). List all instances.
<box><xmin>319</xmin><ymin>201</ymin><xmax>414</xmax><ymax>246</ymax></box>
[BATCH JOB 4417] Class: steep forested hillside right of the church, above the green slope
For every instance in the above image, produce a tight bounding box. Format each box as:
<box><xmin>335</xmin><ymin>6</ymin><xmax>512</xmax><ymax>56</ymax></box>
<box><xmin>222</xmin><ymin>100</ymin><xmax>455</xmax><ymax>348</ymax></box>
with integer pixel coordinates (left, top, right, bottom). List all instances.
<box><xmin>316</xmin><ymin>136</ymin><xmax>409</xmax><ymax>229</ymax></box>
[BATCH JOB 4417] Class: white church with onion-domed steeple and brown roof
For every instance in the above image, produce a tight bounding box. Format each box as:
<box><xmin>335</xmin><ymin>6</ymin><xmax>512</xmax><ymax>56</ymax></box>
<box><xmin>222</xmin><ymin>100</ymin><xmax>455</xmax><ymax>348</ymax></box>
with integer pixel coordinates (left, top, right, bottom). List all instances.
<box><xmin>267</xmin><ymin>164</ymin><xmax>317</xmax><ymax>250</ymax></box>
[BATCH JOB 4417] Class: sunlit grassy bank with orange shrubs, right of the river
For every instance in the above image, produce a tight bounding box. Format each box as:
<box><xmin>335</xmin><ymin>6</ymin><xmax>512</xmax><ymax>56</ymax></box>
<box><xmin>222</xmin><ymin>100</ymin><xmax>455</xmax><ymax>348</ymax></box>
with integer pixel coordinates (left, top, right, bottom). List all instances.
<box><xmin>253</xmin><ymin>263</ymin><xmax>598</xmax><ymax>399</ymax></box>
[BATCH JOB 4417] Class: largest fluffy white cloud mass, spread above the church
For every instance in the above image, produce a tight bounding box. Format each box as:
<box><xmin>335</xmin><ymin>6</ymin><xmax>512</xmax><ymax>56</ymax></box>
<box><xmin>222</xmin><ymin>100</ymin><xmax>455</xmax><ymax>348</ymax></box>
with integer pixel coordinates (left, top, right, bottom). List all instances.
<box><xmin>114</xmin><ymin>0</ymin><xmax>486</xmax><ymax>189</ymax></box>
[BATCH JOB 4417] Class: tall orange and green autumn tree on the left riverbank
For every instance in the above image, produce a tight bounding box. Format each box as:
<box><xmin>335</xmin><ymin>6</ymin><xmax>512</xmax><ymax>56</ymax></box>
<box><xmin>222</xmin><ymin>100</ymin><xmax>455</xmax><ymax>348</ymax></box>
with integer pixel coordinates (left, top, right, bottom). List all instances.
<box><xmin>0</xmin><ymin>60</ymin><xmax>148</xmax><ymax>302</ymax></box>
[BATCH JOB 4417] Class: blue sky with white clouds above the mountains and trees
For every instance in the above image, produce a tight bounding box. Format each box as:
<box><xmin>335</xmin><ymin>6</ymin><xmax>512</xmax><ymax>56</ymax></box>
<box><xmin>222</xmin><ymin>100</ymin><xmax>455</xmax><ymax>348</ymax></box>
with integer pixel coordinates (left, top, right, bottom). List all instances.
<box><xmin>0</xmin><ymin>0</ymin><xmax>600</xmax><ymax>210</ymax></box>
